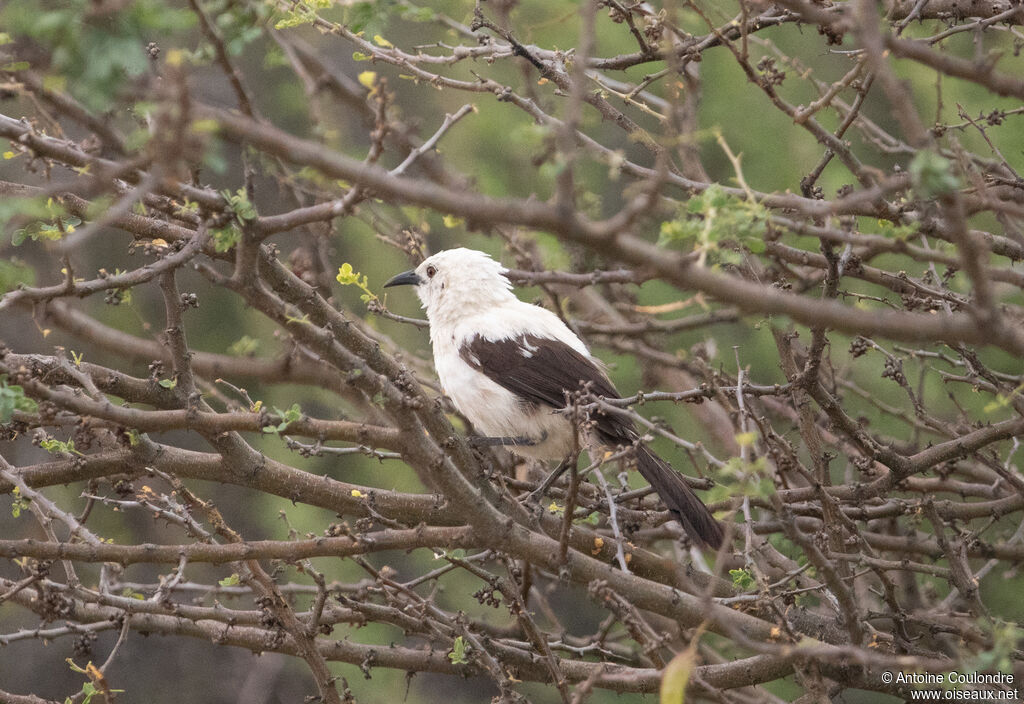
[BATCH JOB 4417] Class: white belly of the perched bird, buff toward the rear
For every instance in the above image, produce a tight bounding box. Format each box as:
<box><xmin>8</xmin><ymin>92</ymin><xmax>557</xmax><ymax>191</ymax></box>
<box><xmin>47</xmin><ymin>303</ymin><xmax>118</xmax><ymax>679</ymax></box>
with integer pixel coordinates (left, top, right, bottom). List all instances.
<box><xmin>434</xmin><ymin>349</ymin><xmax>573</xmax><ymax>459</ymax></box>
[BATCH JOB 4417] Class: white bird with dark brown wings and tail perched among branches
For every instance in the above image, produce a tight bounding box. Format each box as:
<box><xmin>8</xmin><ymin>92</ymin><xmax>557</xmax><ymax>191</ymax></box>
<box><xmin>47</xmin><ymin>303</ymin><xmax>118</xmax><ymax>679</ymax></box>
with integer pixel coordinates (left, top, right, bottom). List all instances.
<box><xmin>384</xmin><ymin>248</ymin><xmax>724</xmax><ymax>548</ymax></box>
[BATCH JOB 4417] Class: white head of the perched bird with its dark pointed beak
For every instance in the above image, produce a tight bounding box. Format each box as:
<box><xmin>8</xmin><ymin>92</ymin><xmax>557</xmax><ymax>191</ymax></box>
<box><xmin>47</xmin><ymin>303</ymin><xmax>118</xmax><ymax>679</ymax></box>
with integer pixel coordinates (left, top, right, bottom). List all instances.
<box><xmin>384</xmin><ymin>248</ymin><xmax>516</xmax><ymax>322</ymax></box>
